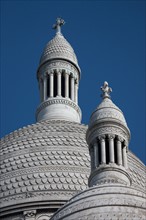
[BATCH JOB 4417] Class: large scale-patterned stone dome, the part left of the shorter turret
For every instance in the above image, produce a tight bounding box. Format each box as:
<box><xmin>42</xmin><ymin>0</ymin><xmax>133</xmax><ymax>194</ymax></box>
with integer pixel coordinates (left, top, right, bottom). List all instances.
<box><xmin>0</xmin><ymin>120</ymin><xmax>90</xmax><ymax>216</ymax></box>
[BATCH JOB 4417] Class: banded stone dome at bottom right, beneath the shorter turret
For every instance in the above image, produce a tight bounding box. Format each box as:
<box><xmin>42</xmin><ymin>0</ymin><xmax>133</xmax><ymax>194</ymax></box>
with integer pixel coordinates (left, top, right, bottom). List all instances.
<box><xmin>51</xmin><ymin>183</ymin><xmax>146</xmax><ymax>220</ymax></box>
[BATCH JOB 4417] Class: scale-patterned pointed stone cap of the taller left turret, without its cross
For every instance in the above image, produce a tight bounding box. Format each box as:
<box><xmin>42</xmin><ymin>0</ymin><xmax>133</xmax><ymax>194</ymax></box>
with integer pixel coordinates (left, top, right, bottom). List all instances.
<box><xmin>40</xmin><ymin>33</ymin><xmax>80</xmax><ymax>70</ymax></box>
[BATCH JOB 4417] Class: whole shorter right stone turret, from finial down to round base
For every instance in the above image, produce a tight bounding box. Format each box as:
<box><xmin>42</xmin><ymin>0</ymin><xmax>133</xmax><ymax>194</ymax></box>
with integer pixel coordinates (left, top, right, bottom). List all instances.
<box><xmin>86</xmin><ymin>82</ymin><xmax>131</xmax><ymax>186</ymax></box>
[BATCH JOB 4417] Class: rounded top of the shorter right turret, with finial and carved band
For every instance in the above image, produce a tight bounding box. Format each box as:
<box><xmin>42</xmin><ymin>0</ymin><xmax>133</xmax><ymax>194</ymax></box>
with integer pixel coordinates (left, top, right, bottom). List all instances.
<box><xmin>86</xmin><ymin>81</ymin><xmax>130</xmax><ymax>144</ymax></box>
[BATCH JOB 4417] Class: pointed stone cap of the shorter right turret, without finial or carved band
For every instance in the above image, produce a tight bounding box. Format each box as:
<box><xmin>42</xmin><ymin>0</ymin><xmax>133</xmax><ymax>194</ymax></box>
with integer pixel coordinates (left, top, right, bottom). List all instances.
<box><xmin>89</xmin><ymin>98</ymin><xmax>127</xmax><ymax>127</ymax></box>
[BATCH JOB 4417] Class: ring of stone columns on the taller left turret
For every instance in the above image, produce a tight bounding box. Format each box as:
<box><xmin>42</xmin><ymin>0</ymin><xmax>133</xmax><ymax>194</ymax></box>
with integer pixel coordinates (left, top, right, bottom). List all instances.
<box><xmin>39</xmin><ymin>70</ymin><xmax>78</xmax><ymax>104</ymax></box>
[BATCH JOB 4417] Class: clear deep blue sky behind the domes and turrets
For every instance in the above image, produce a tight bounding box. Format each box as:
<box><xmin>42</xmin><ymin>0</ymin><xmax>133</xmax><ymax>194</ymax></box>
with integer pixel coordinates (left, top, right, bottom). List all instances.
<box><xmin>1</xmin><ymin>0</ymin><xmax>146</xmax><ymax>162</ymax></box>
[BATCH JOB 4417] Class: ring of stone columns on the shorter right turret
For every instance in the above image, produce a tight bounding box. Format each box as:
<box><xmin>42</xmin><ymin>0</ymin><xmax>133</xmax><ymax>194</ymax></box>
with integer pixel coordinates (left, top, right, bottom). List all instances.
<box><xmin>90</xmin><ymin>135</ymin><xmax>128</xmax><ymax>170</ymax></box>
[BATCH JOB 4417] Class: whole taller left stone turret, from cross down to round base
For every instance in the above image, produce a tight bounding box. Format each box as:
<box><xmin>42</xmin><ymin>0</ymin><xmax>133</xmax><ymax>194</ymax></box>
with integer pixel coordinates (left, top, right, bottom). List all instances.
<box><xmin>36</xmin><ymin>18</ymin><xmax>81</xmax><ymax>123</ymax></box>
